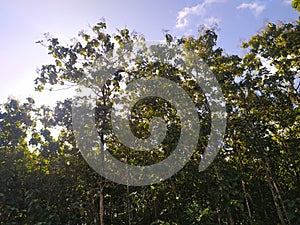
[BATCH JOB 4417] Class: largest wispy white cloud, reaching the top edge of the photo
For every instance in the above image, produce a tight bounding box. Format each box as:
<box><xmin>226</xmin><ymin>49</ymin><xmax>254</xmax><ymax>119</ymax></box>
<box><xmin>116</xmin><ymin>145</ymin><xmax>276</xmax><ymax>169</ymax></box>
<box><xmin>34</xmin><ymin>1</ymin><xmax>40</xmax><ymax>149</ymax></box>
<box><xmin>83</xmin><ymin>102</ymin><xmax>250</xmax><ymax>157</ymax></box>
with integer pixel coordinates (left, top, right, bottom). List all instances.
<box><xmin>176</xmin><ymin>0</ymin><xmax>224</xmax><ymax>28</ymax></box>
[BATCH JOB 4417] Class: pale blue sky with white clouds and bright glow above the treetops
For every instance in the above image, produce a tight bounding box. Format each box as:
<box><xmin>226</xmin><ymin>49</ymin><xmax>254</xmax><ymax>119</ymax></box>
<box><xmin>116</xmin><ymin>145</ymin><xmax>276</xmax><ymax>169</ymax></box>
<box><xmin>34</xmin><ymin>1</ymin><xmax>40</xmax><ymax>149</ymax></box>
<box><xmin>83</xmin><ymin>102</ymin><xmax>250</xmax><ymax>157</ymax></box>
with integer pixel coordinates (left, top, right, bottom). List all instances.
<box><xmin>0</xmin><ymin>0</ymin><xmax>298</xmax><ymax>104</ymax></box>
